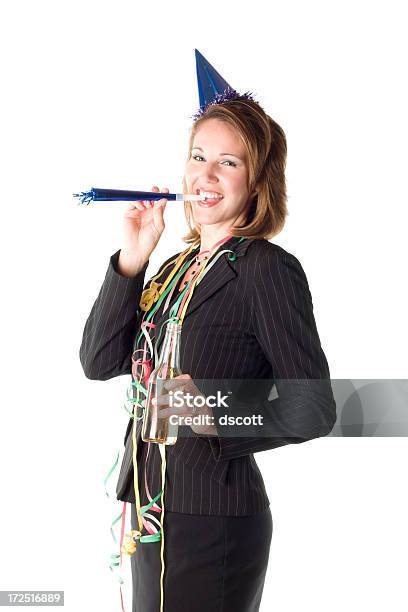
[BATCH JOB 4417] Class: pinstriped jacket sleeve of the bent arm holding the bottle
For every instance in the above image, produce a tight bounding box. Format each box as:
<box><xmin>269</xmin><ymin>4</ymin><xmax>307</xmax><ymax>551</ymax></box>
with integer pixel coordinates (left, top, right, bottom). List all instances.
<box><xmin>208</xmin><ymin>244</ymin><xmax>336</xmax><ymax>460</ymax></box>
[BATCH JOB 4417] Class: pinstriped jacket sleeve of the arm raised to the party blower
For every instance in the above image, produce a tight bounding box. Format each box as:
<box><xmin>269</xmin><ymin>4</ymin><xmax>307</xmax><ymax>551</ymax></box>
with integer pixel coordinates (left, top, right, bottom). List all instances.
<box><xmin>79</xmin><ymin>250</ymin><xmax>149</xmax><ymax>380</ymax></box>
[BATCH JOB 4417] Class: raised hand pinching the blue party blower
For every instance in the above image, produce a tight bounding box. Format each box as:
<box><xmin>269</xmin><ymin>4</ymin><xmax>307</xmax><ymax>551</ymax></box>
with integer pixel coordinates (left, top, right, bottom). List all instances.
<box><xmin>118</xmin><ymin>185</ymin><xmax>169</xmax><ymax>276</ymax></box>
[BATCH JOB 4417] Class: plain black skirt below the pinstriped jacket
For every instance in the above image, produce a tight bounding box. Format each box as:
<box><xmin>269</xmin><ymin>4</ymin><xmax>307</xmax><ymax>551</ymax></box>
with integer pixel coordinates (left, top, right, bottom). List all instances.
<box><xmin>131</xmin><ymin>504</ymin><xmax>272</xmax><ymax>612</ymax></box>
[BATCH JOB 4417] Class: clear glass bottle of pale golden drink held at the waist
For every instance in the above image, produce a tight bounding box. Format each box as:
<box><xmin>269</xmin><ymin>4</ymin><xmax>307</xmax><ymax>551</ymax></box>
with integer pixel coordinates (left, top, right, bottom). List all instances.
<box><xmin>142</xmin><ymin>322</ymin><xmax>182</xmax><ymax>444</ymax></box>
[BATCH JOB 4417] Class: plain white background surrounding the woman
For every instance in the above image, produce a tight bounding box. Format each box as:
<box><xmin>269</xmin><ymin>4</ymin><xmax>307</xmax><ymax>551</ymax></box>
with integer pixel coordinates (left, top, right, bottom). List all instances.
<box><xmin>0</xmin><ymin>0</ymin><xmax>408</xmax><ymax>612</ymax></box>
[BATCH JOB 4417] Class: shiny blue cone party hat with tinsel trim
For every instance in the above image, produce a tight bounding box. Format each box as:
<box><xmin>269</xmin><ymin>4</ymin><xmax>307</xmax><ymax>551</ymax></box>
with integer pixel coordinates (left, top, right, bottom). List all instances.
<box><xmin>193</xmin><ymin>49</ymin><xmax>254</xmax><ymax>120</ymax></box>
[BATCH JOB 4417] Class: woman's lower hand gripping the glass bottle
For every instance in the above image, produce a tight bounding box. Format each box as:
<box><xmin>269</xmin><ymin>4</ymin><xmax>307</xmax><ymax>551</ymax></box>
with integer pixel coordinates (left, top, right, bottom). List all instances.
<box><xmin>145</xmin><ymin>374</ymin><xmax>217</xmax><ymax>436</ymax></box>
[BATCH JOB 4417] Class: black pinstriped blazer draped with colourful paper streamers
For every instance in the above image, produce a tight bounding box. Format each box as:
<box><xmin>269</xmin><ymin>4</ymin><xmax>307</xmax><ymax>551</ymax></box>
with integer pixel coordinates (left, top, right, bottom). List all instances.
<box><xmin>80</xmin><ymin>237</ymin><xmax>336</xmax><ymax>516</ymax></box>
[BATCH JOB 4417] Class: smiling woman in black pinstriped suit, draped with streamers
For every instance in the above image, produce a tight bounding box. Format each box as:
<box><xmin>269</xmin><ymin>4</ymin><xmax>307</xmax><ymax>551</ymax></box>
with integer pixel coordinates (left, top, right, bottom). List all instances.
<box><xmin>80</xmin><ymin>97</ymin><xmax>336</xmax><ymax>612</ymax></box>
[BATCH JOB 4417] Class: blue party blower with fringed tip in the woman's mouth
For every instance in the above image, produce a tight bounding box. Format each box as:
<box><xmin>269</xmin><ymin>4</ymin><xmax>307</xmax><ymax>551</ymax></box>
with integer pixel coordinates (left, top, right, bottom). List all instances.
<box><xmin>73</xmin><ymin>187</ymin><xmax>211</xmax><ymax>204</ymax></box>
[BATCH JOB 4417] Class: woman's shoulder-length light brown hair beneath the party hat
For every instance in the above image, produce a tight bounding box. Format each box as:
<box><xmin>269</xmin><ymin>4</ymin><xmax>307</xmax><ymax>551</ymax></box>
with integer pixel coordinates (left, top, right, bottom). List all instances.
<box><xmin>183</xmin><ymin>99</ymin><xmax>288</xmax><ymax>243</ymax></box>
